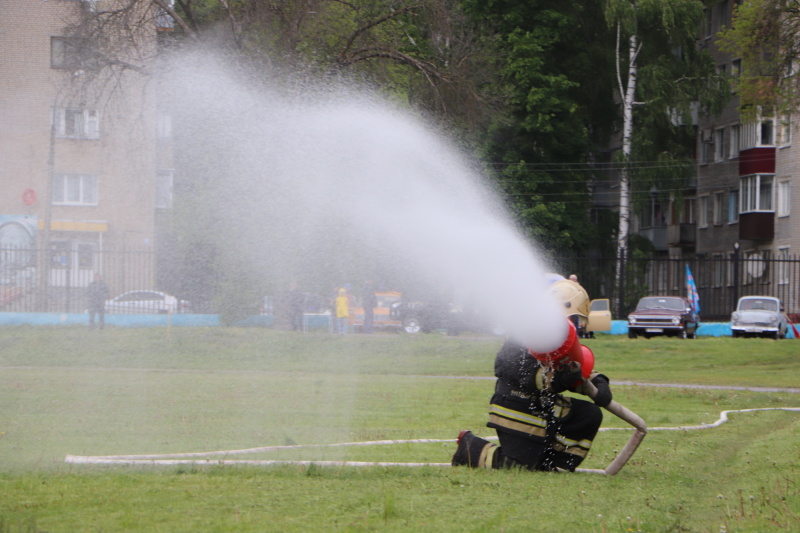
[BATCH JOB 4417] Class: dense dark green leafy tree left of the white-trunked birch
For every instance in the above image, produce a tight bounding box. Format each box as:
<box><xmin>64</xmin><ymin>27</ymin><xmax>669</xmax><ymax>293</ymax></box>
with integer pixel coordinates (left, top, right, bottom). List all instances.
<box><xmin>456</xmin><ymin>0</ymin><xmax>614</xmax><ymax>255</ymax></box>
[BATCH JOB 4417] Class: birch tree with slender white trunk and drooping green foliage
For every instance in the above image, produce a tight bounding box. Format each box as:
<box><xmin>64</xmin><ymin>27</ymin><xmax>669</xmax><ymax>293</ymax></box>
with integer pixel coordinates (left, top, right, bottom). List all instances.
<box><xmin>605</xmin><ymin>0</ymin><xmax>729</xmax><ymax>282</ymax></box>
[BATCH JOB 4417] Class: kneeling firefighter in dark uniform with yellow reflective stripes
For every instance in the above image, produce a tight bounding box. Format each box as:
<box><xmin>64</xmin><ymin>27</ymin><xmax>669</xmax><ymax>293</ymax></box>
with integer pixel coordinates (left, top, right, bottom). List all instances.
<box><xmin>452</xmin><ymin>282</ymin><xmax>611</xmax><ymax>472</ymax></box>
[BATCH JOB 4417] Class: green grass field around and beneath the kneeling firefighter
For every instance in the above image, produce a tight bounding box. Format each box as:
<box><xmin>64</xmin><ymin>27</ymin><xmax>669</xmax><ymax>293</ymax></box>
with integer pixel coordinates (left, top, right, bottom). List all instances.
<box><xmin>0</xmin><ymin>327</ymin><xmax>800</xmax><ymax>533</ymax></box>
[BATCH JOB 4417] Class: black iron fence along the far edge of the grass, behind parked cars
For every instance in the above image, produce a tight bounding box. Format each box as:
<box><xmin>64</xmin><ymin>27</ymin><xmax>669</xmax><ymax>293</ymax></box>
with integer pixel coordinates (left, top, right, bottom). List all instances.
<box><xmin>0</xmin><ymin>246</ymin><xmax>800</xmax><ymax>321</ymax></box>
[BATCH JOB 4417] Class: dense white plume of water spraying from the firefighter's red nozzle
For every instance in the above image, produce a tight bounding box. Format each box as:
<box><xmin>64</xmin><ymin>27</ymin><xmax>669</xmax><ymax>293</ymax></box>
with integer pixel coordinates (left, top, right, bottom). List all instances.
<box><xmin>164</xmin><ymin>50</ymin><xmax>566</xmax><ymax>351</ymax></box>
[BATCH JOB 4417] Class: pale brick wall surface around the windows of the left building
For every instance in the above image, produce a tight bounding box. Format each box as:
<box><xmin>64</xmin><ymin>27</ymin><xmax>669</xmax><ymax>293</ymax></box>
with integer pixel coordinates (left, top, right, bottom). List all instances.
<box><xmin>0</xmin><ymin>0</ymin><xmax>164</xmax><ymax>289</ymax></box>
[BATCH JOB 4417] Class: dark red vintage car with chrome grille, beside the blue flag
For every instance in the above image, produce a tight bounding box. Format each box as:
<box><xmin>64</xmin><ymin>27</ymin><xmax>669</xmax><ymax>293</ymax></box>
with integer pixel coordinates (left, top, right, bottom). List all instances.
<box><xmin>628</xmin><ymin>296</ymin><xmax>700</xmax><ymax>339</ymax></box>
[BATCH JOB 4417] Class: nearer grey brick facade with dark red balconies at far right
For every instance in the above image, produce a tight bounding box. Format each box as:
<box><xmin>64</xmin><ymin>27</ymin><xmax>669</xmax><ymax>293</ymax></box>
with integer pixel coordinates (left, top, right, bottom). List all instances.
<box><xmin>692</xmin><ymin>1</ymin><xmax>800</xmax><ymax>284</ymax></box>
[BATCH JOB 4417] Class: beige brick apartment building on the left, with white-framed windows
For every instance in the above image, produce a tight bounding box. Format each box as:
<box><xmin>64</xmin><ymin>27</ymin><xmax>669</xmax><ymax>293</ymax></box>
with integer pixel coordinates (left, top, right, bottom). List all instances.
<box><xmin>0</xmin><ymin>0</ymin><xmax>172</xmax><ymax>300</ymax></box>
